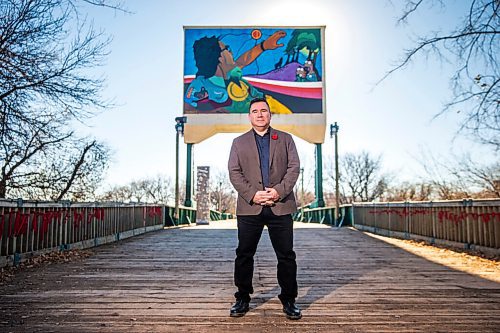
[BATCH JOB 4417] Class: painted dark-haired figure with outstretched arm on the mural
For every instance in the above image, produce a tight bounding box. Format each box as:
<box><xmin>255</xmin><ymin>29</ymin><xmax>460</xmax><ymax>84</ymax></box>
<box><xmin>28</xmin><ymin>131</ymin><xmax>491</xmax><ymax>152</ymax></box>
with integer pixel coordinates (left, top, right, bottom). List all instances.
<box><xmin>184</xmin><ymin>30</ymin><xmax>291</xmax><ymax>113</ymax></box>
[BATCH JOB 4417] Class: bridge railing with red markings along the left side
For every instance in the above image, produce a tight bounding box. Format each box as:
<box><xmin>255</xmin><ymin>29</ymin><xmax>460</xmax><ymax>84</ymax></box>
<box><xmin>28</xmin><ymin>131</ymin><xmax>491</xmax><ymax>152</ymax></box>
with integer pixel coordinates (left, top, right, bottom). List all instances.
<box><xmin>0</xmin><ymin>200</ymin><xmax>196</xmax><ymax>267</ymax></box>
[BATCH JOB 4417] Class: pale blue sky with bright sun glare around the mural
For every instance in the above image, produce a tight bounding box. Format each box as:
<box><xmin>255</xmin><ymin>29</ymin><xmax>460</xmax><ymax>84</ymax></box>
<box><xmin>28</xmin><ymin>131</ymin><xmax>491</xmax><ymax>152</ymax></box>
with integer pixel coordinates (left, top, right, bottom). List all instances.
<box><xmin>79</xmin><ymin>0</ymin><xmax>491</xmax><ymax>189</ymax></box>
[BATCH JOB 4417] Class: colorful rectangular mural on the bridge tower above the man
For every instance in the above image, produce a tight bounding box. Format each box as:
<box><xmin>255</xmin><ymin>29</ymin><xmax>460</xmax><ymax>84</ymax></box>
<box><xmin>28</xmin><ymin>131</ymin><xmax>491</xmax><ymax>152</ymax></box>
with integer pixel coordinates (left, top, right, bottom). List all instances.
<box><xmin>184</xmin><ymin>27</ymin><xmax>324</xmax><ymax>115</ymax></box>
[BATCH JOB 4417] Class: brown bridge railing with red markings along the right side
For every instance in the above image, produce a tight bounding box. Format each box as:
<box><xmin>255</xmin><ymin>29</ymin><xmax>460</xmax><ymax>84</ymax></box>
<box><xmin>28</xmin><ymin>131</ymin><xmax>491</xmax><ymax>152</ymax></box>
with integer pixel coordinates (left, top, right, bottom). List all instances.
<box><xmin>352</xmin><ymin>199</ymin><xmax>500</xmax><ymax>249</ymax></box>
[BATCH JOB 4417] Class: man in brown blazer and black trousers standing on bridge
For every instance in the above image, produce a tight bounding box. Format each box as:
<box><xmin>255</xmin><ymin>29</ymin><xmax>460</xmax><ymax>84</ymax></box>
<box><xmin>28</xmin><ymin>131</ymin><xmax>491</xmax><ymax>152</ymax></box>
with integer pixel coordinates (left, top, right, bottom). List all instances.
<box><xmin>228</xmin><ymin>98</ymin><xmax>302</xmax><ymax>319</ymax></box>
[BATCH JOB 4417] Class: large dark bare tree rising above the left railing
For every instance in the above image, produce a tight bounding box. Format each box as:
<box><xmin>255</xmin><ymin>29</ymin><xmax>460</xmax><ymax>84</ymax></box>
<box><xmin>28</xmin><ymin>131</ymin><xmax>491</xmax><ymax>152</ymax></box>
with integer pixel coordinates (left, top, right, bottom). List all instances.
<box><xmin>0</xmin><ymin>0</ymin><xmax>124</xmax><ymax>200</ymax></box>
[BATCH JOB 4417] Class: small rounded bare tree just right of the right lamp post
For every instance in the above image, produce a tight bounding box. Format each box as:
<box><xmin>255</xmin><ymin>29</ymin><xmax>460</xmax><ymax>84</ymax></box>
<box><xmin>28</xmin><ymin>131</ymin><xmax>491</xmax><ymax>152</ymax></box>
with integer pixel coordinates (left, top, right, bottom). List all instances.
<box><xmin>339</xmin><ymin>151</ymin><xmax>389</xmax><ymax>201</ymax></box>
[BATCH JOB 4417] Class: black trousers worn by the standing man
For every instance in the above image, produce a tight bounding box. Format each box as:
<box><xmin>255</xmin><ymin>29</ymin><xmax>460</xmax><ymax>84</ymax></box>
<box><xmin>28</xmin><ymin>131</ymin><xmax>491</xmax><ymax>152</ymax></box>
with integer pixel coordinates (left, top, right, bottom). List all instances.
<box><xmin>234</xmin><ymin>207</ymin><xmax>297</xmax><ymax>303</ymax></box>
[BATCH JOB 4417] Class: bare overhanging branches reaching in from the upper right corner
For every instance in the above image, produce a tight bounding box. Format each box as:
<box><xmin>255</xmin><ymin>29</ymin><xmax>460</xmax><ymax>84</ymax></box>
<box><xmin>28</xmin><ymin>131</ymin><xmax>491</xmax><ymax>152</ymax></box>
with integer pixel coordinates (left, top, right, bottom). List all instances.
<box><xmin>381</xmin><ymin>0</ymin><xmax>500</xmax><ymax>151</ymax></box>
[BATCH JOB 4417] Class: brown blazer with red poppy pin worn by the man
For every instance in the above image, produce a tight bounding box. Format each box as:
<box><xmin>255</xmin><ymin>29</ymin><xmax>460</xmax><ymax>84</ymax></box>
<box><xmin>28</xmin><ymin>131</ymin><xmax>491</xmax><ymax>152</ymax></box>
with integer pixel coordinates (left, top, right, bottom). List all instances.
<box><xmin>228</xmin><ymin>128</ymin><xmax>300</xmax><ymax>215</ymax></box>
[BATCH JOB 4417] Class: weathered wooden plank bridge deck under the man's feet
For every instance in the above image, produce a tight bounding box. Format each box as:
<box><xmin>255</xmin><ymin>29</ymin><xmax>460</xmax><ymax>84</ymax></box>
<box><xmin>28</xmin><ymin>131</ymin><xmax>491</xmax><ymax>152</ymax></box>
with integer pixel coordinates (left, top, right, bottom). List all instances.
<box><xmin>0</xmin><ymin>222</ymin><xmax>500</xmax><ymax>332</ymax></box>
